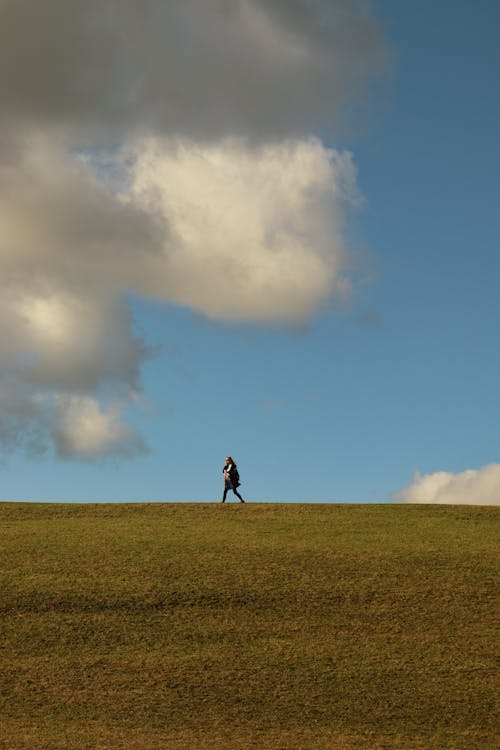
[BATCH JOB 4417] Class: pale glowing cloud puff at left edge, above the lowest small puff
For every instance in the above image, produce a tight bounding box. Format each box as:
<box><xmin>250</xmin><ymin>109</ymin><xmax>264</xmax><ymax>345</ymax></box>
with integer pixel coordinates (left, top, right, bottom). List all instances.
<box><xmin>0</xmin><ymin>287</ymin><xmax>146</xmax><ymax>391</ymax></box>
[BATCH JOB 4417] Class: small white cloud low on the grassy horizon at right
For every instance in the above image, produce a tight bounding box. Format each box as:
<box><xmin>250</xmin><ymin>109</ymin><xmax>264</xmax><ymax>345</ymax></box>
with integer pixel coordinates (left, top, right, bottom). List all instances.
<box><xmin>393</xmin><ymin>464</ymin><xmax>500</xmax><ymax>505</ymax></box>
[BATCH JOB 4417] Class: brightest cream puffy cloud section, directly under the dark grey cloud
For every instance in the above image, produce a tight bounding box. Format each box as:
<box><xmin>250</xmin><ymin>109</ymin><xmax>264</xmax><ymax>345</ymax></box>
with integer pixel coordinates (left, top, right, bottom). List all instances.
<box><xmin>132</xmin><ymin>139</ymin><xmax>358</xmax><ymax>323</ymax></box>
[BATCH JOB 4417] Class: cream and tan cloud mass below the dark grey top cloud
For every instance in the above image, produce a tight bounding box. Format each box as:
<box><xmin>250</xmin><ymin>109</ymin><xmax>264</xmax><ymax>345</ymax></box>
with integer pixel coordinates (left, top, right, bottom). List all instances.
<box><xmin>0</xmin><ymin>138</ymin><xmax>359</xmax><ymax>458</ymax></box>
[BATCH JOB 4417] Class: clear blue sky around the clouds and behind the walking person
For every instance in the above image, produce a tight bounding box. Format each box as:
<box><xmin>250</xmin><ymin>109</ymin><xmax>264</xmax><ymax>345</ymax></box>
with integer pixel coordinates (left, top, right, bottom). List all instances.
<box><xmin>0</xmin><ymin>0</ymin><xmax>500</xmax><ymax>503</ymax></box>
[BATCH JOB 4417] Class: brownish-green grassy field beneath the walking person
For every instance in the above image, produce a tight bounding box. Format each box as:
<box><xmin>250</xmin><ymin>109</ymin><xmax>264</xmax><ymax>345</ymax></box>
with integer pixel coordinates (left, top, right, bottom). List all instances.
<box><xmin>0</xmin><ymin>503</ymin><xmax>499</xmax><ymax>750</ymax></box>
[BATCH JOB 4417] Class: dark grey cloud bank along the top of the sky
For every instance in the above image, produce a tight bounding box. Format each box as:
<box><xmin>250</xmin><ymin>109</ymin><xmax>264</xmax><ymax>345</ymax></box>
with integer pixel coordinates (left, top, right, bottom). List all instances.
<box><xmin>0</xmin><ymin>0</ymin><xmax>383</xmax><ymax>140</ymax></box>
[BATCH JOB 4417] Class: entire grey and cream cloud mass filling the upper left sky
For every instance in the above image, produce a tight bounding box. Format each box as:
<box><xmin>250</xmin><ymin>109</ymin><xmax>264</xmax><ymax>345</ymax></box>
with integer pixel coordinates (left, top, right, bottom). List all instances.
<box><xmin>0</xmin><ymin>0</ymin><xmax>383</xmax><ymax>460</ymax></box>
